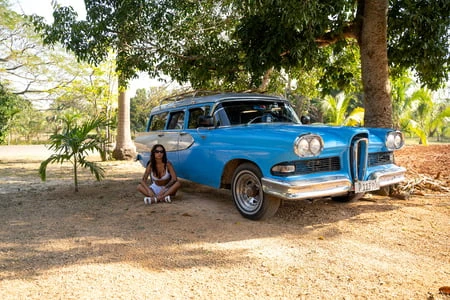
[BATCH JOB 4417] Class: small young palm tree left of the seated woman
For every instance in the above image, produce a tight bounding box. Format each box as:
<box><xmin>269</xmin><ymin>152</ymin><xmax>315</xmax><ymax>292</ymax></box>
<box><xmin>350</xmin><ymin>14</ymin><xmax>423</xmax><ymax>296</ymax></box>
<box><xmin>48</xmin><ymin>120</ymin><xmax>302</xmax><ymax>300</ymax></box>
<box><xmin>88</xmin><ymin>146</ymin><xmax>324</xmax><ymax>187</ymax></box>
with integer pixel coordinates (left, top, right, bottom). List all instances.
<box><xmin>39</xmin><ymin>115</ymin><xmax>109</xmax><ymax>192</ymax></box>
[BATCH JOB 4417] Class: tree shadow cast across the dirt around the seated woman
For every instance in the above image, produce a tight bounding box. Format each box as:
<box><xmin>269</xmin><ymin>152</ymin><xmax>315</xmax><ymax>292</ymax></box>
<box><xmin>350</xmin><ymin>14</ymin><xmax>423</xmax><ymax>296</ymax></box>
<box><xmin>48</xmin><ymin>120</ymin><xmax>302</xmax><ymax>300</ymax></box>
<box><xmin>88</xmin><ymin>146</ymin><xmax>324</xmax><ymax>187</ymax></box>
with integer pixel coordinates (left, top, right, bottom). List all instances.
<box><xmin>0</xmin><ymin>164</ymin><xmax>410</xmax><ymax>279</ymax></box>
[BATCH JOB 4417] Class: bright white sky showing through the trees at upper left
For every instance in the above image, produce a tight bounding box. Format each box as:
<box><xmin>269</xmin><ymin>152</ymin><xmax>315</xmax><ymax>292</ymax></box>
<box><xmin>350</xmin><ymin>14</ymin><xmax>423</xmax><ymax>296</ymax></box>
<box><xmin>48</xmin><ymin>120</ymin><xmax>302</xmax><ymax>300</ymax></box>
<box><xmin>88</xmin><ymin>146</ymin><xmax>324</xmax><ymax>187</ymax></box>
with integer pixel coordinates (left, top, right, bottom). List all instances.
<box><xmin>9</xmin><ymin>0</ymin><xmax>171</xmax><ymax>97</ymax></box>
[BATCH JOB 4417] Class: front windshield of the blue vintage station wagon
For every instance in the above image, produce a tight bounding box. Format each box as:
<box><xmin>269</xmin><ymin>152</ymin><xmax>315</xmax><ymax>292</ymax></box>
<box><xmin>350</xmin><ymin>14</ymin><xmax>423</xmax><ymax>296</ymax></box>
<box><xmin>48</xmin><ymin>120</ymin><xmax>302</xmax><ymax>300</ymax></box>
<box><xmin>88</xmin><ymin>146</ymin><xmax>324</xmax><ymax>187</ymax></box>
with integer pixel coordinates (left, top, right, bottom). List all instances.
<box><xmin>216</xmin><ymin>100</ymin><xmax>300</xmax><ymax>125</ymax></box>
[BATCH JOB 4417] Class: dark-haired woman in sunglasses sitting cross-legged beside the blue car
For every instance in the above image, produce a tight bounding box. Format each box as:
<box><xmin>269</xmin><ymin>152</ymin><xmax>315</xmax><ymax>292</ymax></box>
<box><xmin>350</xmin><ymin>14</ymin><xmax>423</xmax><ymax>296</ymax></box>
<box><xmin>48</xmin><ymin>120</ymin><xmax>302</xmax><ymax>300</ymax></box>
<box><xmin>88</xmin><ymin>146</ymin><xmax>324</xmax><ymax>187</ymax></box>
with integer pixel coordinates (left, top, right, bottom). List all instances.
<box><xmin>137</xmin><ymin>144</ymin><xmax>181</xmax><ymax>204</ymax></box>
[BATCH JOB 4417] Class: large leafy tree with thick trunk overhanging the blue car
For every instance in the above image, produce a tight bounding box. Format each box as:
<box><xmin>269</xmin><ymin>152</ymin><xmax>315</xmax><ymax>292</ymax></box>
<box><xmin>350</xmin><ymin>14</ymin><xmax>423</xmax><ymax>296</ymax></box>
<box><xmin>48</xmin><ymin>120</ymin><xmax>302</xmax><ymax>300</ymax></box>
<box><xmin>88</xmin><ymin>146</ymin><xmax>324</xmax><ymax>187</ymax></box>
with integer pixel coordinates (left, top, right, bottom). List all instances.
<box><xmin>30</xmin><ymin>0</ymin><xmax>450</xmax><ymax>127</ymax></box>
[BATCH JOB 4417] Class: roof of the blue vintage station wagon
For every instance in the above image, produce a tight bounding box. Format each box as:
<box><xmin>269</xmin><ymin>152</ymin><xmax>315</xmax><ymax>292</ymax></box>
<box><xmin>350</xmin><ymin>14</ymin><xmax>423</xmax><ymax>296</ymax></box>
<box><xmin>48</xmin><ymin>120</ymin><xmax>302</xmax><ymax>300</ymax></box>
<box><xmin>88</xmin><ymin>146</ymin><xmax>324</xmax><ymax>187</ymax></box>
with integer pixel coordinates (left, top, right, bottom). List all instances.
<box><xmin>152</xmin><ymin>93</ymin><xmax>287</xmax><ymax>112</ymax></box>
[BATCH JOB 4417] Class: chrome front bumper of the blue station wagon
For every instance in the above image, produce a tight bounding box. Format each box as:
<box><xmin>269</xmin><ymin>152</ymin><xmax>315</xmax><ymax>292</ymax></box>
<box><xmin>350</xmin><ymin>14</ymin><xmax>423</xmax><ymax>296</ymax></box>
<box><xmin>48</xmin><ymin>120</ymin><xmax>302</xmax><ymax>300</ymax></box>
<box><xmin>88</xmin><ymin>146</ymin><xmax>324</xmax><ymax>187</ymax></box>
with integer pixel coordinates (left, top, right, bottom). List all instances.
<box><xmin>261</xmin><ymin>166</ymin><xmax>406</xmax><ymax>200</ymax></box>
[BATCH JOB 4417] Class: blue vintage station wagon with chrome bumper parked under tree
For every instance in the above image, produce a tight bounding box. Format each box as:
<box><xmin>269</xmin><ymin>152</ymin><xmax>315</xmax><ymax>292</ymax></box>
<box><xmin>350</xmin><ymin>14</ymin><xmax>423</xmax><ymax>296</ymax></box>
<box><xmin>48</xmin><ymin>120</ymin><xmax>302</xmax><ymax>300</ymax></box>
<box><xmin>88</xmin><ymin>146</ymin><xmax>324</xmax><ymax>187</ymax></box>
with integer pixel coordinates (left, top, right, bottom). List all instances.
<box><xmin>135</xmin><ymin>94</ymin><xmax>406</xmax><ymax>220</ymax></box>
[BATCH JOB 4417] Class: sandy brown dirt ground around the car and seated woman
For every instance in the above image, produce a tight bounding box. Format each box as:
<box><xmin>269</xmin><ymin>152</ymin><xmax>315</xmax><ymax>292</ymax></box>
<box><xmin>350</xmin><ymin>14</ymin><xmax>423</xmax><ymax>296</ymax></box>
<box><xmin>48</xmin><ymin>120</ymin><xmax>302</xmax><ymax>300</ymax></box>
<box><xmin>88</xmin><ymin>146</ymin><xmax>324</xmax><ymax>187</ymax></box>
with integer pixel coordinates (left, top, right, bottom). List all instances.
<box><xmin>0</xmin><ymin>144</ymin><xmax>450</xmax><ymax>299</ymax></box>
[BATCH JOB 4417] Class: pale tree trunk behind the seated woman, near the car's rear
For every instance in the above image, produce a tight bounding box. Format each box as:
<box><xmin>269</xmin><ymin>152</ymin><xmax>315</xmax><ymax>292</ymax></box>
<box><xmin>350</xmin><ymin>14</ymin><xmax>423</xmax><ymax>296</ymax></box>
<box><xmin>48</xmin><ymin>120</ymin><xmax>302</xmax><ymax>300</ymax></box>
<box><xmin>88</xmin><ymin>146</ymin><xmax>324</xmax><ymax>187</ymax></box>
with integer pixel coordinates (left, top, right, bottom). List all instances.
<box><xmin>112</xmin><ymin>79</ymin><xmax>136</xmax><ymax>160</ymax></box>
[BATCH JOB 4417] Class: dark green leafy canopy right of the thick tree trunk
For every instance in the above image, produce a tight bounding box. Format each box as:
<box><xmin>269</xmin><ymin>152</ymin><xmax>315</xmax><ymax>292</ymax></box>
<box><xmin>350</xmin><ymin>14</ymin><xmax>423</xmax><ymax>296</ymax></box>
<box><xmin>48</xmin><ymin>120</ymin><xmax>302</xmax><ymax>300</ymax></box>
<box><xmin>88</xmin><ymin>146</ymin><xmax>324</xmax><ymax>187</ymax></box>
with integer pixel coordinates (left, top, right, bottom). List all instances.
<box><xmin>388</xmin><ymin>0</ymin><xmax>450</xmax><ymax>90</ymax></box>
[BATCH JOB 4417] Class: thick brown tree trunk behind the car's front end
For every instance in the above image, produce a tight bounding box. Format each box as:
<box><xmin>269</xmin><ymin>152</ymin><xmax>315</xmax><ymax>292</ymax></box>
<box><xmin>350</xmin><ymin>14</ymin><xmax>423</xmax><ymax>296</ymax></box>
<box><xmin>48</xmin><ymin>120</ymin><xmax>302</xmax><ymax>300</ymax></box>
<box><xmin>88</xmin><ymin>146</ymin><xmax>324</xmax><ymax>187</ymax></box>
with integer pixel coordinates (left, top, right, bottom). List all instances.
<box><xmin>358</xmin><ymin>0</ymin><xmax>393</xmax><ymax>128</ymax></box>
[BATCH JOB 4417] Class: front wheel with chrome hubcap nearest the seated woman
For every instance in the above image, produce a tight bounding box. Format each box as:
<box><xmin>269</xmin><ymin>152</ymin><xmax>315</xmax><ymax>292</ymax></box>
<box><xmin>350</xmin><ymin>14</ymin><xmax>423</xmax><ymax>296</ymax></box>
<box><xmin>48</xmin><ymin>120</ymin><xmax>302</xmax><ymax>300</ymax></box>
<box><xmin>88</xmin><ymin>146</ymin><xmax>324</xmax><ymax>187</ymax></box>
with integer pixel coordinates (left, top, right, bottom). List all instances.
<box><xmin>231</xmin><ymin>163</ymin><xmax>281</xmax><ymax>220</ymax></box>
